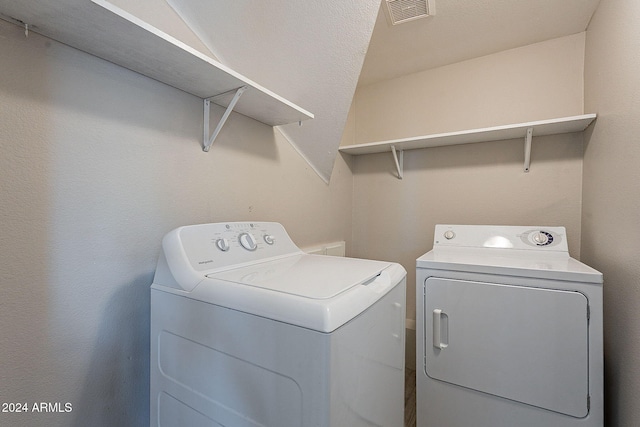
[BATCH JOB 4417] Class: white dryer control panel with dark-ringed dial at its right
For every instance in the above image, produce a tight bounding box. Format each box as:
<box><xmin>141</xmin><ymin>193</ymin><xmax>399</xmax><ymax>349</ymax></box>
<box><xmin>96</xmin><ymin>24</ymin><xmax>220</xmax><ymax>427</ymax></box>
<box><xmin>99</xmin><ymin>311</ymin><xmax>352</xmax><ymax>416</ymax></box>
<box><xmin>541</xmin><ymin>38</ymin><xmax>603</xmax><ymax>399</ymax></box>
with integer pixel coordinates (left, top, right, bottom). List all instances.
<box><xmin>433</xmin><ymin>224</ymin><xmax>569</xmax><ymax>252</ymax></box>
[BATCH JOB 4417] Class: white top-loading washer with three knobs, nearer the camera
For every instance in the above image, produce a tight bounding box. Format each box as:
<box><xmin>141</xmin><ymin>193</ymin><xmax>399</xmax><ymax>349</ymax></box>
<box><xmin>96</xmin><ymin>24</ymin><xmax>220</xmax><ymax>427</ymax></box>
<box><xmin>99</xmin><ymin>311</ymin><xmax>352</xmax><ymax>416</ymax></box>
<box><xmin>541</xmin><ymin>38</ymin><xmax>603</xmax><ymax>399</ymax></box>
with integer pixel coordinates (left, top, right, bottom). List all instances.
<box><xmin>150</xmin><ymin>222</ymin><xmax>406</xmax><ymax>427</ymax></box>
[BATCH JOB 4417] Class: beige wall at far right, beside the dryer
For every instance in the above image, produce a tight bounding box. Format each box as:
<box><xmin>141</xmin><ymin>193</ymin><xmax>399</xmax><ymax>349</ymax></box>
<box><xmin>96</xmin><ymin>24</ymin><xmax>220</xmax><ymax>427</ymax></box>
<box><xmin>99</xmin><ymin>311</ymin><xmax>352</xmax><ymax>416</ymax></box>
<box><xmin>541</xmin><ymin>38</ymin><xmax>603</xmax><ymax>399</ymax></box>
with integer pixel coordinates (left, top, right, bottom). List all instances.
<box><xmin>582</xmin><ymin>0</ymin><xmax>640</xmax><ymax>427</ymax></box>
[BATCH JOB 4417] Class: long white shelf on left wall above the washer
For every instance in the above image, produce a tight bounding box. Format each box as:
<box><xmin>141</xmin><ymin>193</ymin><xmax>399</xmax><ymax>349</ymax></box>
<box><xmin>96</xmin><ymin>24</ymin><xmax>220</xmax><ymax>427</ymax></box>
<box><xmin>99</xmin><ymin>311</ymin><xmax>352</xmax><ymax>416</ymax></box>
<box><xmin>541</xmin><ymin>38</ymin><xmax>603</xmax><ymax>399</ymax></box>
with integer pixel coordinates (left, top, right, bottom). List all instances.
<box><xmin>0</xmin><ymin>0</ymin><xmax>313</xmax><ymax>152</ymax></box>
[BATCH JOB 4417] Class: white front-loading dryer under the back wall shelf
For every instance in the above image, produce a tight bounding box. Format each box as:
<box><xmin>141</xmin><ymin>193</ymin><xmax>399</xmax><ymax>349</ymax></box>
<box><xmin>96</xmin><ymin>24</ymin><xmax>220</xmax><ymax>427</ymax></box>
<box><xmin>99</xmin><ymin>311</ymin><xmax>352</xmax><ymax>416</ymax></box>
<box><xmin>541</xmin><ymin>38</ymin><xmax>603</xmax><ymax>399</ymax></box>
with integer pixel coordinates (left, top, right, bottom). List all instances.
<box><xmin>416</xmin><ymin>225</ymin><xmax>603</xmax><ymax>427</ymax></box>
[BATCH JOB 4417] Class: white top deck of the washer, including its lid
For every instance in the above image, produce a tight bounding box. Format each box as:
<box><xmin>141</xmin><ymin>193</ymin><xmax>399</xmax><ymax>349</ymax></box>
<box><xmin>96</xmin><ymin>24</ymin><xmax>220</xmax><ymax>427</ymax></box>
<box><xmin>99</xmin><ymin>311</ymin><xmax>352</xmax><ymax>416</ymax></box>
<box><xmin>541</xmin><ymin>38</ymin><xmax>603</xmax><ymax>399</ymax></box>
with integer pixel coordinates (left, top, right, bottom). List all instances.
<box><xmin>172</xmin><ymin>254</ymin><xmax>406</xmax><ymax>333</ymax></box>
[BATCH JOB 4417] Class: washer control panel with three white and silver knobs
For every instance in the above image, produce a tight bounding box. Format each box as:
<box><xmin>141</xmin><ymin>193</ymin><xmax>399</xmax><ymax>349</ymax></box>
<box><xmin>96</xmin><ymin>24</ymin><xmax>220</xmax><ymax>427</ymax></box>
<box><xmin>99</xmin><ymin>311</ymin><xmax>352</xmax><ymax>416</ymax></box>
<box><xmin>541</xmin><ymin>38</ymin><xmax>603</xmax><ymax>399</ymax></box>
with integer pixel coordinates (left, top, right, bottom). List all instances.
<box><xmin>171</xmin><ymin>222</ymin><xmax>302</xmax><ymax>271</ymax></box>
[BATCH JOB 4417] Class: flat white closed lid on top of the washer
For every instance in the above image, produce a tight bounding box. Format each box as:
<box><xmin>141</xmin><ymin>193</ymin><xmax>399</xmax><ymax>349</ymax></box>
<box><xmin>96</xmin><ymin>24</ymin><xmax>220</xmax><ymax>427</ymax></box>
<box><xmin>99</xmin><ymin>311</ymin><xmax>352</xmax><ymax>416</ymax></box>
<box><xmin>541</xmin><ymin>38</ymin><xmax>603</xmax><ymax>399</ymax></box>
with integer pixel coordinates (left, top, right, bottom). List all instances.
<box><xmin>207</xmin><ymin>254</ymin><xmax>390</xmax><ymax>300</ymax></box>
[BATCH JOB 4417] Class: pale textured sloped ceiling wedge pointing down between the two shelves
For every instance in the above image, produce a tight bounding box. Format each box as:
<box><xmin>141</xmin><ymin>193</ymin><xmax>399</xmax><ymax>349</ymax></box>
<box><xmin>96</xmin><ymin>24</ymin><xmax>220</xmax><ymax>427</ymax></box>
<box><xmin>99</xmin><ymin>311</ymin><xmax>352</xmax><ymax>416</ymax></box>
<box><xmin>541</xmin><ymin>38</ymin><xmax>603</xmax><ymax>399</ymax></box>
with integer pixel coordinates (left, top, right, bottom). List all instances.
<box><xmin>167</xmin><ymin>0</ymin><xmax>380</xmax><ymax>182</ymax></box>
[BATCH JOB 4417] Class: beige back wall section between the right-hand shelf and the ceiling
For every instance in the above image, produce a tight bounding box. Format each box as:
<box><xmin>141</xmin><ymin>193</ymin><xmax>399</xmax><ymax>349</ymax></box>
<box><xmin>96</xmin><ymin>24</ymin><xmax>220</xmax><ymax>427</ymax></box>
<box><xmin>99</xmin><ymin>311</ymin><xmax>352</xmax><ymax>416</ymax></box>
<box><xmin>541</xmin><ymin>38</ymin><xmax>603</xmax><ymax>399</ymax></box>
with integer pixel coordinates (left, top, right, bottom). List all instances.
<box><xmin>350</xmin><ymin>33</ymin><xmax>585</xmax><ymax>143</ymax></box>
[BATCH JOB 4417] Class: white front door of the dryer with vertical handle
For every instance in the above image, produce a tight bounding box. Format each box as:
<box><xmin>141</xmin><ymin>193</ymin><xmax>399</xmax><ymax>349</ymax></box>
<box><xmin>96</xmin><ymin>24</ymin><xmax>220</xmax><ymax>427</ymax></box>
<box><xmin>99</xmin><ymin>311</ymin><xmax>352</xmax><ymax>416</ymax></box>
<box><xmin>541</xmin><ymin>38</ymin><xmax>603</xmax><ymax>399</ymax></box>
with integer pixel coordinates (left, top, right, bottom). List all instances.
<box><xmin>424</xmin><ymin>277</ymin><xmax>589</xmax><ymax>417</ymax></box>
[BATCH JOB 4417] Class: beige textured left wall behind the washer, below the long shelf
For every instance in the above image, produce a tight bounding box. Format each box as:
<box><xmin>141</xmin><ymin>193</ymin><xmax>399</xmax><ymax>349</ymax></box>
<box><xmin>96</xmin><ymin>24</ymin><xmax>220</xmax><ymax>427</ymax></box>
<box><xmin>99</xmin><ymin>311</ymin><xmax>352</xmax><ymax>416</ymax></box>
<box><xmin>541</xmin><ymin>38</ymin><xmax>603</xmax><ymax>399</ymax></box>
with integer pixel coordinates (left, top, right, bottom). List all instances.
<box><xmin>0</xmin><ymin>20</ymin><xmax>352</xmax><ymax>427</ymax></box>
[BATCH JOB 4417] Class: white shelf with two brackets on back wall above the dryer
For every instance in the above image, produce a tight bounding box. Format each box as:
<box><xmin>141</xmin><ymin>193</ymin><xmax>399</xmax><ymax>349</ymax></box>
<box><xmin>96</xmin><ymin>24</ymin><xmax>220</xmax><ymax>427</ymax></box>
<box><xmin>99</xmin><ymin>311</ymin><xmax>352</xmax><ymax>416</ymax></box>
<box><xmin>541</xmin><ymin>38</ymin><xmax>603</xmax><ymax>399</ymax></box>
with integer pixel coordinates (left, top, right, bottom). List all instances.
<box><xmin>340</xmin><ymin>114</ymin><xmax>596</xmax><ymax>179</ymax></box>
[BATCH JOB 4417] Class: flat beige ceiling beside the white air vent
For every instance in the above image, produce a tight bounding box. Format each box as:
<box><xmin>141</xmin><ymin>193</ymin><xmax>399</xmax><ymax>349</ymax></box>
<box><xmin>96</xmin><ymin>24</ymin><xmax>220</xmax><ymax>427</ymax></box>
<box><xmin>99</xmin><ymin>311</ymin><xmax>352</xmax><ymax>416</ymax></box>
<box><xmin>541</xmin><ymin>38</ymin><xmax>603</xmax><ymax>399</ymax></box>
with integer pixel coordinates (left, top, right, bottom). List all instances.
<box><xmin>358</xmin><ymin>0</ymin><xmax>600</xmax><ymax>86</ymax></box>
